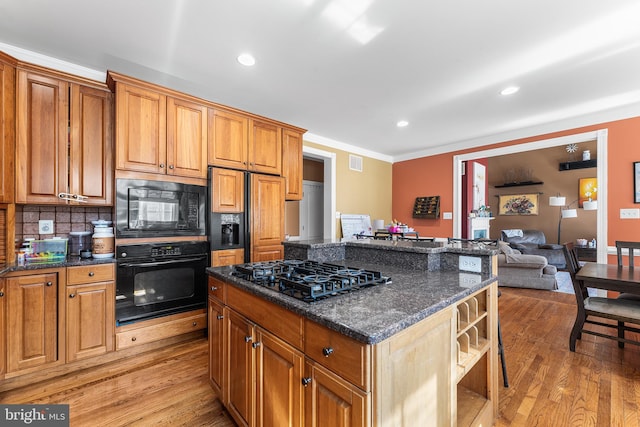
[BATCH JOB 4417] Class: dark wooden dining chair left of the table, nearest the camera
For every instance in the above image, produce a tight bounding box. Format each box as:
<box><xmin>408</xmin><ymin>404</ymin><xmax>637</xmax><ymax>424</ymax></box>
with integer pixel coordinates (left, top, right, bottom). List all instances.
<box><xmin>563</xmin><ymin>242</ymin><xmax>640</xmax><ymax>352</ymax></box>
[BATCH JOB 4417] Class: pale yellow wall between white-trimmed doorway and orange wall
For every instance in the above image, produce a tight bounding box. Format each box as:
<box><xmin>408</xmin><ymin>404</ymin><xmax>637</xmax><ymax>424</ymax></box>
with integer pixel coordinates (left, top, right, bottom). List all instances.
<box><xmin>304</xmin><ymin>141</ymin><xmax>392</xmax><ymax>237</ymax></box>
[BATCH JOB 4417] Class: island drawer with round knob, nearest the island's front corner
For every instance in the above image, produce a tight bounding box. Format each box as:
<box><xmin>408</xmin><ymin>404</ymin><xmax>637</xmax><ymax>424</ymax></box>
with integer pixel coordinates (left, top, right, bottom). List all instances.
<box><xmin>304</xmin><ymin>320</ymin><xmax>371</xmax><ymax>391</ymax></box>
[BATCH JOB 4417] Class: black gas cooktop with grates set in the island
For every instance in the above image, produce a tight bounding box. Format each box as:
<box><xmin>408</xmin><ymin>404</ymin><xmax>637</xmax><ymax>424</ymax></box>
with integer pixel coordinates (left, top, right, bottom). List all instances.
<box><xmin>233</xmin><ymin>260</ymin><xmax>391</xmax><ymax>302</ymax></box>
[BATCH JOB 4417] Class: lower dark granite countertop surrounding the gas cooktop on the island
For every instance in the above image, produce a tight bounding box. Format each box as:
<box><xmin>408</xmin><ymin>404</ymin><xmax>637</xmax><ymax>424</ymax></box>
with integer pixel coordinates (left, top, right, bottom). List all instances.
<box><xmin>207</xmin><ymin>260</ymin><xmax>497</xmax><ymax>344</ymax></box>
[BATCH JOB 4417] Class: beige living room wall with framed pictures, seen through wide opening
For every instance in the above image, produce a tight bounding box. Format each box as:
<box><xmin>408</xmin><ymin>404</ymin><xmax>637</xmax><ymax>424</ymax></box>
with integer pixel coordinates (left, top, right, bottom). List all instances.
<box><xmin>487</xmin><ymin>141</ymin><xmax>597</xmax><ymax>243</ymax></box>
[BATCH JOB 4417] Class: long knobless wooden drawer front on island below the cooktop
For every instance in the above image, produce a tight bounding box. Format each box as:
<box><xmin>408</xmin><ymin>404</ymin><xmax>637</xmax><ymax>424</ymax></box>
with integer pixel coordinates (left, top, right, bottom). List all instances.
<box><xmin>226</xmin><ymin>286</ymin><xmax>303</xmax><ymax>350</ymax></box>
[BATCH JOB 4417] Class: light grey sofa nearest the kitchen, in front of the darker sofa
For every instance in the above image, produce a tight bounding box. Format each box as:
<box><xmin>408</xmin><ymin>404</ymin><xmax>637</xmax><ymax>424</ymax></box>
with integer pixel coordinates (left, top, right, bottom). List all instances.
<box><xmin>498</xmin><ymin>242</ymin><xmax>558</xmax><ymax>290</ymax></box>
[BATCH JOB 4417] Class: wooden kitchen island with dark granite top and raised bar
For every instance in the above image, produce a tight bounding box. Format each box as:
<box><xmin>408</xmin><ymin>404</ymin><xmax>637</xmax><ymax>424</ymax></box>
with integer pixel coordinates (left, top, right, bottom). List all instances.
<box><xmin>208</xmin><ymin>240</ymin><xmax>497</xmax><ymax>426</ymax></box>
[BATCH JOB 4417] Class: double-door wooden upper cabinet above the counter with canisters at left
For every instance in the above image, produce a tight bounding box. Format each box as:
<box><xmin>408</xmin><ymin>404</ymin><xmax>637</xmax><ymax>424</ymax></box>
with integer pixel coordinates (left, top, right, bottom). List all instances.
<box><xmin>16</xmin><ymin>69</ymin><xmax>113</xmax><ymax>205</ymax></box>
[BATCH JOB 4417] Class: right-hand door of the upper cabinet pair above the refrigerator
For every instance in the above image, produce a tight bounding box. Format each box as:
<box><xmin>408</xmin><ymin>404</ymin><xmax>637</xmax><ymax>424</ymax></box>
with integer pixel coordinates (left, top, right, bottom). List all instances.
<box><xmin>248</xmin><ymin>119</ymin><xmax>282</xmax><ymax>175</ymax></box>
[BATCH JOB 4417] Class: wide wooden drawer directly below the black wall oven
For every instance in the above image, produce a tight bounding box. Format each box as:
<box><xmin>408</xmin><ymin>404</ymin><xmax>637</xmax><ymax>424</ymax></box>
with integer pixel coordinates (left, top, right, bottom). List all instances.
<box><xmin>116</xmin><ymin>313</ymin><xmax>207</xmax><ymax>350</ymax></box>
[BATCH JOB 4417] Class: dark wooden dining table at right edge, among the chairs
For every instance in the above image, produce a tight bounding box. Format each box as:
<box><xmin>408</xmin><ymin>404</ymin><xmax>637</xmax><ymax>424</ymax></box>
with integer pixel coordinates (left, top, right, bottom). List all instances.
<box><xmin>576</xmin><ymin>262</ymin><xmax>640</xmax><ymax>295</ymax></box>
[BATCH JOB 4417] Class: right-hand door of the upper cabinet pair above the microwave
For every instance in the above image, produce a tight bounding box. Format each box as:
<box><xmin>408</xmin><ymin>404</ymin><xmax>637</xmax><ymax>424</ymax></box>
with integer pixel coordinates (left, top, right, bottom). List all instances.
<box><xmin>167</xmin><ymin>97</ymin><xmax>207</xmax><ymax>179</ymax></box>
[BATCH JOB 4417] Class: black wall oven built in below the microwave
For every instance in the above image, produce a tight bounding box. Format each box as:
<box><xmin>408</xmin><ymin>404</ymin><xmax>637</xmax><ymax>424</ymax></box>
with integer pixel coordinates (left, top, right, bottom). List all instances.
<box><xmin>116</xmin><ymin>241</ymin><xmax>209</xmax><ymax>325</ymax></box>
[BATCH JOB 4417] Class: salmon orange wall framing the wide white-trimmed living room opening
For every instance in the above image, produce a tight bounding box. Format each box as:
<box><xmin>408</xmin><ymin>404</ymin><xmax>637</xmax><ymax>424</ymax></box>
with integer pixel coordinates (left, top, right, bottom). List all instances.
<box><xmin>392</xmin><ymin>117</ymin><xmax>640</xmax><ymax>262</ymax></box>
